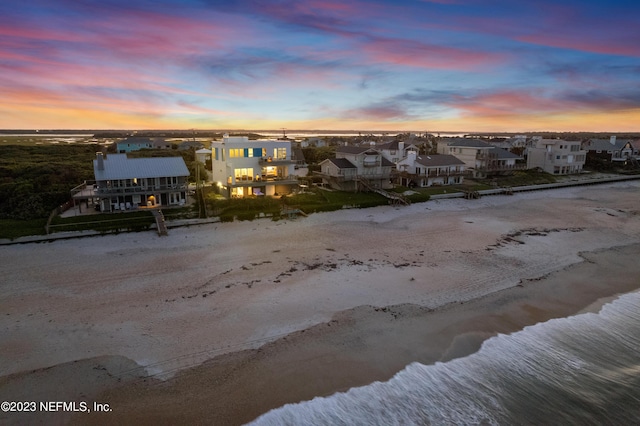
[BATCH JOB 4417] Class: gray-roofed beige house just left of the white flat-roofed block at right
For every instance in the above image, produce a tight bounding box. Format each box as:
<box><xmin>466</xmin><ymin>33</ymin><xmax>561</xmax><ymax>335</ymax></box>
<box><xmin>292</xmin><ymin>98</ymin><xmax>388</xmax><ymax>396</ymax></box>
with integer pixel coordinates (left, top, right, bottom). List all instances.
<box><xmin>437</xmin><ymin>138</ymin><xmax>526</xmax><ymax>178</ymax></box>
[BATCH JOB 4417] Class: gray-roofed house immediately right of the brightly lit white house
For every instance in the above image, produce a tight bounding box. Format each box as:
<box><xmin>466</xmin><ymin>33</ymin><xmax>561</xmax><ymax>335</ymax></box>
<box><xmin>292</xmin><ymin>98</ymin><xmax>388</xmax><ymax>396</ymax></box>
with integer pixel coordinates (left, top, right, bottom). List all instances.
<box><xmin>316</xmin><ymin>146</ymin><xmax>394</xmax><ymax>192</ymax></box>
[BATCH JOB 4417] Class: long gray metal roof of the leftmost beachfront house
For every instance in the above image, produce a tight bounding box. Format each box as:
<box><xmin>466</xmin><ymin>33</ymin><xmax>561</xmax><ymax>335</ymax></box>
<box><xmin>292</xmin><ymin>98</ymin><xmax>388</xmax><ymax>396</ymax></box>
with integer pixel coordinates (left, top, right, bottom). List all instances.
<box><xmin>93</xmin><ymin>154</ymin><xmax>189</xmax><ymax>181</ymax></box>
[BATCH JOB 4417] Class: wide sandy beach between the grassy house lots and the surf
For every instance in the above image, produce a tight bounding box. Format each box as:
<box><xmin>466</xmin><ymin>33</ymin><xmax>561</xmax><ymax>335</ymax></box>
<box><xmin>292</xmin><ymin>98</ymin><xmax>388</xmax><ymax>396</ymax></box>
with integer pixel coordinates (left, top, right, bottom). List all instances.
<box><xmin>0</xmin><ymin>181</ymin><xmax>640</xmax><ymax>425</ymax></box>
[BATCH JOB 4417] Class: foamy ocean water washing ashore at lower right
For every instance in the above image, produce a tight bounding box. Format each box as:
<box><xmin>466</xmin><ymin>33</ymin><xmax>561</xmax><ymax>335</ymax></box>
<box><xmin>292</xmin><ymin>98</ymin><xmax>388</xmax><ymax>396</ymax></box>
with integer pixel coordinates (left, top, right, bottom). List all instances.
<box><xmin>254</xmin><ymin>292</ymin><xmax>640</xmax><ymax>426</ymax></box>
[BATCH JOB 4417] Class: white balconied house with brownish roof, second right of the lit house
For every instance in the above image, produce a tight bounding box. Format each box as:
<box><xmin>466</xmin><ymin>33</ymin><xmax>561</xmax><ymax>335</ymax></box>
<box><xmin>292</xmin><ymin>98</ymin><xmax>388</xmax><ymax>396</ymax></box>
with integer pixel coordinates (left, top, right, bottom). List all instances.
<box><xmin>396</xmin><ymin>151</ymin><xmax>467</xmax><ymax>188</ymax></box>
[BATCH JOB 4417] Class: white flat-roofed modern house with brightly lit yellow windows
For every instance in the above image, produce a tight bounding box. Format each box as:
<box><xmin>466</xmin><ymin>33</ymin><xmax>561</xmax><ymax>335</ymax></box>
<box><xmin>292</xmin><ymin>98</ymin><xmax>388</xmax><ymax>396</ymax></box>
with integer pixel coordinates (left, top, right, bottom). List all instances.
<box><xmin>211</xmin><ymin>135</ymin><xmax>298</xmax><ymax>198</ymax></box>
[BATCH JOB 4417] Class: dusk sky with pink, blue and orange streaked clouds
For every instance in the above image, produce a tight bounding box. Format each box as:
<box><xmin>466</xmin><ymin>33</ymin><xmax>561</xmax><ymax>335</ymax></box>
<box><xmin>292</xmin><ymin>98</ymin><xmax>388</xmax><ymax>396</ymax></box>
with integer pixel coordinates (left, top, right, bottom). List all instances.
<box><xmin>0</xmin><ymin>0</ymin><xmax>640</xmax><ymax>132</ymax></box>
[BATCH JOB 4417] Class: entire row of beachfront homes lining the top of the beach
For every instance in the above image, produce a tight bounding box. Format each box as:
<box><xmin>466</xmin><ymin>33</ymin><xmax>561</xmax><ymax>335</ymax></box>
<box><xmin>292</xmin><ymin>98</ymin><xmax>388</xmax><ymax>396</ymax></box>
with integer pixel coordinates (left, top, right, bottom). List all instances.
<box><xmin>72</xmin><ymin>135</ymin><xmax>640</xmax><ymax>212</ymax></box>
